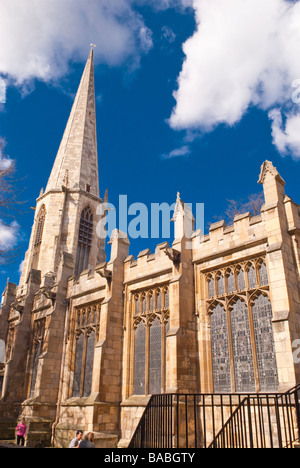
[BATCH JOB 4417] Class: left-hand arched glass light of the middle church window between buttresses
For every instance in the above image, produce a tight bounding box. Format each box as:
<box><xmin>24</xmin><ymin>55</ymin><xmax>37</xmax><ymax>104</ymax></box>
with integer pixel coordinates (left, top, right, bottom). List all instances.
<box><xmin>134</xmin><ymin>322</ymin><xmax>146</xmax><ymax>395</ymax></box>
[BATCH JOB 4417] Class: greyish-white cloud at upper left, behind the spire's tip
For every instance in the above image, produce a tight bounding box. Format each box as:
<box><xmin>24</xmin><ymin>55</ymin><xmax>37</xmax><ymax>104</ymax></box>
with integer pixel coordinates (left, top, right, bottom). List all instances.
<box><xmin>0</xmin><ymin>0</ymin><xmax>152</xmax><ymax>92</ymax></box>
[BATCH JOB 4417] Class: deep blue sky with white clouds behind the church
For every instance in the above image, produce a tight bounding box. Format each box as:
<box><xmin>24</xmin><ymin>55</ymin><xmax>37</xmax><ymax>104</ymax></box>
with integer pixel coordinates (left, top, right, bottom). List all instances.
<box><xmin>0</xmin><ymin>0</ymin><xmax>300</xmax><ymax>290</ymax></box>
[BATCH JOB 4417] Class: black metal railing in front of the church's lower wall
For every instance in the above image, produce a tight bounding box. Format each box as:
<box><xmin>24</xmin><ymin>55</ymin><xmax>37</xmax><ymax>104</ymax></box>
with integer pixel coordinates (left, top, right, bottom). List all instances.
<box><xmin>129</xmin><ymin>385</ymin><xmax>300</xmax><ymax>449</ymax></box>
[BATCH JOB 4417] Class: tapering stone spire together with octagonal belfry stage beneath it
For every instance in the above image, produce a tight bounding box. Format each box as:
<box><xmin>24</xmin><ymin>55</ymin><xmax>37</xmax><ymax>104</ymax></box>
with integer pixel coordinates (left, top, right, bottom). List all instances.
<box><xmin>20</xmin><ymin>50</ymin><xmax>105</xmax><ymax>288</ymax></box>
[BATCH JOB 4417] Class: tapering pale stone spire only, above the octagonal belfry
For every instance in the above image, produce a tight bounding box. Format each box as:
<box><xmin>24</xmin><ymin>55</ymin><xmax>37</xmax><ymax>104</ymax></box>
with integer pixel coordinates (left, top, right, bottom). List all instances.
<box><xmin>46</xmin><ymin>49</ymin><xmax>99</xmax><ymax>197</ymax></box>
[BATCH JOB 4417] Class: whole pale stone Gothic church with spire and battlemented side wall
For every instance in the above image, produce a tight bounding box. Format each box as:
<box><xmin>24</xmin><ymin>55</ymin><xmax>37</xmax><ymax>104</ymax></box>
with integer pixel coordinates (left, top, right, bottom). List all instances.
<box><xmin>0</xmin><ymin>50</ymin><xmax>300</xmax><ymax>448</ymax></box>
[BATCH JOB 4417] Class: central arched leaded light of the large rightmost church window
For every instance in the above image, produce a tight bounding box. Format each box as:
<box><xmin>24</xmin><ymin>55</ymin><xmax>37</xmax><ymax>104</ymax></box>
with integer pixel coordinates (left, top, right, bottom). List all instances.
<box><xmin>231</xmin><ymin>299</ymin><xmax>255</xmax><ymax>393</ymax></box>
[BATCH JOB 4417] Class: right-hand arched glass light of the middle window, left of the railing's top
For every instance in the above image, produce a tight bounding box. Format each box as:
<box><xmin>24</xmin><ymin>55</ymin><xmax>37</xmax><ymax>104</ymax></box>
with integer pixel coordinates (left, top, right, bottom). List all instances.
<box><xmin>149</xmin><ymin>318</ymin><xmax>162</xmax><ymax>394</ymax></box>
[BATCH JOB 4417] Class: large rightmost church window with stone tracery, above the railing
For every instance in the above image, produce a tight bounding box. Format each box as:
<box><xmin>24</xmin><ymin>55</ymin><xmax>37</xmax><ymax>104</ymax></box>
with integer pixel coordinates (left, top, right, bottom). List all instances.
<box><xmin>206</xmin><ymin>258</ymin><xmax>278</xmax><ymax>393</ymax></box>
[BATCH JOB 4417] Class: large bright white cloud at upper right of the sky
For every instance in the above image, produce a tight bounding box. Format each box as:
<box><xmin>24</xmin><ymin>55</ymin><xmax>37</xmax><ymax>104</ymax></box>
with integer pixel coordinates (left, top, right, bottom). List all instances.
<box><xmin>170</xmin><ymin>0</ymin><xmax>300</xmax><ymax>157</ymax></box>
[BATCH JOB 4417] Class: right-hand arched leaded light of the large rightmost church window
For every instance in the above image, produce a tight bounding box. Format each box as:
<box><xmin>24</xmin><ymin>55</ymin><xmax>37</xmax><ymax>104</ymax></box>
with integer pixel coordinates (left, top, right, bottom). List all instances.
<box><xmin>252</xmin><ymin>294</ymin><xmax>278</xmax><ymax>391</ymax></box>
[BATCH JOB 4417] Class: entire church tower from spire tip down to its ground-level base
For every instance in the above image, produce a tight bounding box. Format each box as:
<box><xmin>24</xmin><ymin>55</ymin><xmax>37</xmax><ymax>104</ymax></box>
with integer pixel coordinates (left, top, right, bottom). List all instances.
<box><xmin>0</xmin><ymin>49</ymin><xmax>105</xmax><ymax>443</ymax></box>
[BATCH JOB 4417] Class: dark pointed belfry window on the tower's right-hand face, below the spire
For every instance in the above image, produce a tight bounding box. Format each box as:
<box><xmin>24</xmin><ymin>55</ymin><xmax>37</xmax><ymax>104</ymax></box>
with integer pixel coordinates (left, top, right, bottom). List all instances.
<box><xmin>75</xmin><ymin>206</ymin><xmax>93</xmax><ymax>275</ymax></box>
